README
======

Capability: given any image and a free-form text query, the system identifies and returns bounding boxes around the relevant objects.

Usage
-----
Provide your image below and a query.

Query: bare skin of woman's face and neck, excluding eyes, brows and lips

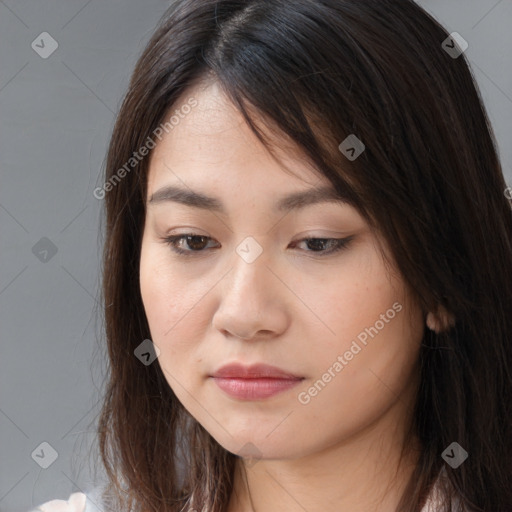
[140,83,425,512]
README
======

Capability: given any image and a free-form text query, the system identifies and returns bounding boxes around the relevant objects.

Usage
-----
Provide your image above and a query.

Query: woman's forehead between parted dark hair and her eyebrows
[148,82,330,193]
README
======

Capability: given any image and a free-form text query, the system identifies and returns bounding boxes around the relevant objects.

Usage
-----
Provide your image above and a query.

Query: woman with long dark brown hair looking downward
[31,0,512,512]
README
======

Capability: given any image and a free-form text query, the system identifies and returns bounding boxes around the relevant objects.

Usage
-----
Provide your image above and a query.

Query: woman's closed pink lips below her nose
[211,363,303,400]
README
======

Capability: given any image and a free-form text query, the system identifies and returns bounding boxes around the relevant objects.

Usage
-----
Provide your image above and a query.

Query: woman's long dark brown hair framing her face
[98,0,512,512]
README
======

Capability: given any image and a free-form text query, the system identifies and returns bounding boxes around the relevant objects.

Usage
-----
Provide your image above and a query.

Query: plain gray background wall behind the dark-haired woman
[0,0,512,512]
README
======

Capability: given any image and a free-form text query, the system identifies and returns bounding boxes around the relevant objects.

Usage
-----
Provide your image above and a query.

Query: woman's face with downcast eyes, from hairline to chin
[140,81,424,459]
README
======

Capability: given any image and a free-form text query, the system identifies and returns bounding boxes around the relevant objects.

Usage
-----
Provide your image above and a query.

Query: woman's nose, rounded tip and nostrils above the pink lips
[212,248,291,340]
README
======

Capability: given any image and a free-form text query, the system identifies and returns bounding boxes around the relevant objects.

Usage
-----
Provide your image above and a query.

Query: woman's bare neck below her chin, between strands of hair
[228,404,420,512]
